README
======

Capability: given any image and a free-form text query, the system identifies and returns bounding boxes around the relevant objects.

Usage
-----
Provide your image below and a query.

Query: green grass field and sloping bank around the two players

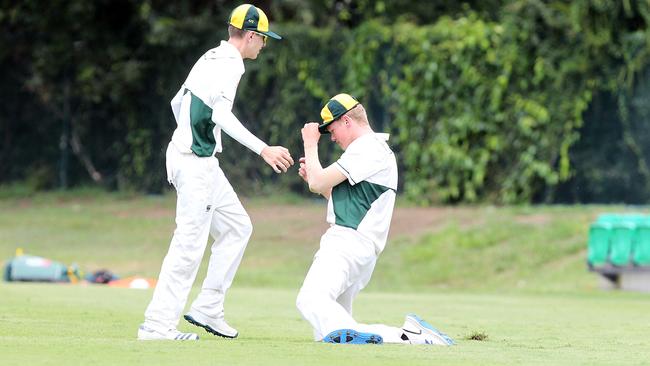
[0,191,650,365]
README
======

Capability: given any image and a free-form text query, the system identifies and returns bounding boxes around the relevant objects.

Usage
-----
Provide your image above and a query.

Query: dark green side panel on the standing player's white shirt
[190,91,216,157]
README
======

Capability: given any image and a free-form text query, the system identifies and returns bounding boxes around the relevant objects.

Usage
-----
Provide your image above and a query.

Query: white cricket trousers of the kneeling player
[296,225,404,343]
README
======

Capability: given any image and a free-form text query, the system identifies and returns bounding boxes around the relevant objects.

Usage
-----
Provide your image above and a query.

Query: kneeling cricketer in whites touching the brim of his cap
[296,94,454,345]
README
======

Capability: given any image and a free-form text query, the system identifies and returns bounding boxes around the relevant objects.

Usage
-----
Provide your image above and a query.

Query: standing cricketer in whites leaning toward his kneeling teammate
[138,4,293,340]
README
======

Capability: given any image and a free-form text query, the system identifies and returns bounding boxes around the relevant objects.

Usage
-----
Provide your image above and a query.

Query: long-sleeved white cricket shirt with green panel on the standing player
[171,41,267,157]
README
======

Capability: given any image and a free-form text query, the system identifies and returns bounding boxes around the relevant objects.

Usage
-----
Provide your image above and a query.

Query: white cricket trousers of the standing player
[145,143,252,330]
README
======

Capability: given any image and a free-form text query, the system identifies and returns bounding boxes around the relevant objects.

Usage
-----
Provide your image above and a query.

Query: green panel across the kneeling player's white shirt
[332,180,391,230]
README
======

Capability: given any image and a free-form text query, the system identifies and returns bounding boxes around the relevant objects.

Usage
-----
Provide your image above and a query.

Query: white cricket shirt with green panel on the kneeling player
[327,133,397,253]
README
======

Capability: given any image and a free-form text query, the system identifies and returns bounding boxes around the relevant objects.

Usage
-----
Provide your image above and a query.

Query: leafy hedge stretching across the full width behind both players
[5,0,650,203]
